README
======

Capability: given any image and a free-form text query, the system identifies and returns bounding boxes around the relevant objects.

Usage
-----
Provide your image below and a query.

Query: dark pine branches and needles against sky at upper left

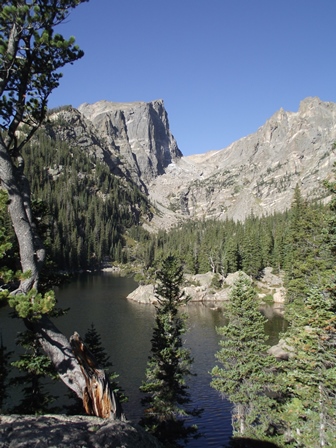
[0,0,86,136]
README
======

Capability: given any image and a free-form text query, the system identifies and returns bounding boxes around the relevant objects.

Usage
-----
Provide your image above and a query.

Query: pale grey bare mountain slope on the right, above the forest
[148,98,336,225]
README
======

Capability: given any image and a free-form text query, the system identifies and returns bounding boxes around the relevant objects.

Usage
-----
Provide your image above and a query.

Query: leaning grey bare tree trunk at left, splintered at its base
[0,141,121,418]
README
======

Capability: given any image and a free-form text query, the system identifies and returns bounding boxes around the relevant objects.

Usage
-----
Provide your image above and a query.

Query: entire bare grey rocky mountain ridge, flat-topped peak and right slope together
[51,98,336,230]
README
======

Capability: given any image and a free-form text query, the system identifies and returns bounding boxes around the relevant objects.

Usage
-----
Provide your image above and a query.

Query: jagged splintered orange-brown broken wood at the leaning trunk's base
[70,332,123,419]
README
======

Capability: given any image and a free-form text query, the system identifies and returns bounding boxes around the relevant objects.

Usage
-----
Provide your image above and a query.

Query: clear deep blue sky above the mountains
[49,0,336,155]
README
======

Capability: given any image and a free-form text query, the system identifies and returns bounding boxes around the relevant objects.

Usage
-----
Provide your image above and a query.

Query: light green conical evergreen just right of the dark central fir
[211,273,276,440]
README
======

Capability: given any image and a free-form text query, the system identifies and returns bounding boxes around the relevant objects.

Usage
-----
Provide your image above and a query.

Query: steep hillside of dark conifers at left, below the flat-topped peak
[21,122,150,271]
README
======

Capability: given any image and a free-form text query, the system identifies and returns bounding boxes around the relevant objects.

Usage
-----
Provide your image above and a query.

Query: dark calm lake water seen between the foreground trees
[0,273,284,448]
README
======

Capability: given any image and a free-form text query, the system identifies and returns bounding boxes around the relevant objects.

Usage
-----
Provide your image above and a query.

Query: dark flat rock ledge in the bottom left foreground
[0,415,162,448]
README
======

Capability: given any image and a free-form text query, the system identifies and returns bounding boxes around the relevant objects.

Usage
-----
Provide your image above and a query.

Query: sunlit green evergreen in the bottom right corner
[280,288,336,448]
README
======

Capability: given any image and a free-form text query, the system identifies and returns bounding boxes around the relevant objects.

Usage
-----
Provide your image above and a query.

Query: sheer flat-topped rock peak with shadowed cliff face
[79,100,182,190]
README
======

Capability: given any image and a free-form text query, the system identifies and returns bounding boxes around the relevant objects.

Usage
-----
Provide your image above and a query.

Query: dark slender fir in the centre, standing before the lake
[140,256,199,446]
